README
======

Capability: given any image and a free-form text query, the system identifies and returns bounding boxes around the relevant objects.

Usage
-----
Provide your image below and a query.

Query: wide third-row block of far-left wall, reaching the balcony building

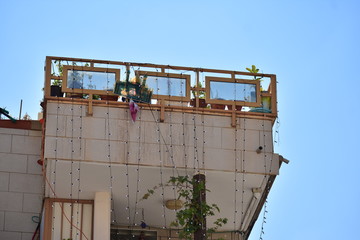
[9,173,43,194]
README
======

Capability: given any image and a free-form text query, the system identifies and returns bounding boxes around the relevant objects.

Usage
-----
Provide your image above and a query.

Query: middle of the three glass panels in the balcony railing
[142,76,186,97]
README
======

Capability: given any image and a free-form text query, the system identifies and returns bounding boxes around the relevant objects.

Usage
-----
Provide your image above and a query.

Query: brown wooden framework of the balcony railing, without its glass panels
[44,56,277,127]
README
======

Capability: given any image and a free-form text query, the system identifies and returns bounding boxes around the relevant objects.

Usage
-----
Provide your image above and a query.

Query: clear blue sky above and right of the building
[0,0,360,240]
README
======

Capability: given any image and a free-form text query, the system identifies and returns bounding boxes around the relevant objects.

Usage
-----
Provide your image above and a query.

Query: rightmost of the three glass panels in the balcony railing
[210,81,256,102]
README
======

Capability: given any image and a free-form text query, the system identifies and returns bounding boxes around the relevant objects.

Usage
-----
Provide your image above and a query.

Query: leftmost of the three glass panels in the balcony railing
[67,70,116,91]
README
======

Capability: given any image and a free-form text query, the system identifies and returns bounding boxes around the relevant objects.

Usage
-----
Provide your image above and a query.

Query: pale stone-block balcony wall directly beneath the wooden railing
[45,103,279,174]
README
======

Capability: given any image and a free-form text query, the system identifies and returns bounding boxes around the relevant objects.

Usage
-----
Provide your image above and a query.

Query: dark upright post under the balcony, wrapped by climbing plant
[193,173,206,240]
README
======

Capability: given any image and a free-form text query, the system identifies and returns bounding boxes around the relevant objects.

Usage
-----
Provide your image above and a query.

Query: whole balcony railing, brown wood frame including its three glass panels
[44,57,277,124]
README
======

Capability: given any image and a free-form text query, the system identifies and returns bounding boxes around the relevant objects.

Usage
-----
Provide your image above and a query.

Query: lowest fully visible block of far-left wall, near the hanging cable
[5,212,37,233]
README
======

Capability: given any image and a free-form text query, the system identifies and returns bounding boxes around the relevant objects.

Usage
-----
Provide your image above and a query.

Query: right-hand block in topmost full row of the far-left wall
[12,135,41,155]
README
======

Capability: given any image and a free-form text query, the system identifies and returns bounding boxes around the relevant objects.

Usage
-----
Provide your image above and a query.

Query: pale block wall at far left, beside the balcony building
[0,128,44,240]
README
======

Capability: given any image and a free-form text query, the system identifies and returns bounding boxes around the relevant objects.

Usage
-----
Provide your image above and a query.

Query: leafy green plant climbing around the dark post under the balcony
[142,176,228,239]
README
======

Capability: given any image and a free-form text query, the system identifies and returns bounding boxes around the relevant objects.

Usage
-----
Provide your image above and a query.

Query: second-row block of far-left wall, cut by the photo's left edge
[0,153,27,173]
